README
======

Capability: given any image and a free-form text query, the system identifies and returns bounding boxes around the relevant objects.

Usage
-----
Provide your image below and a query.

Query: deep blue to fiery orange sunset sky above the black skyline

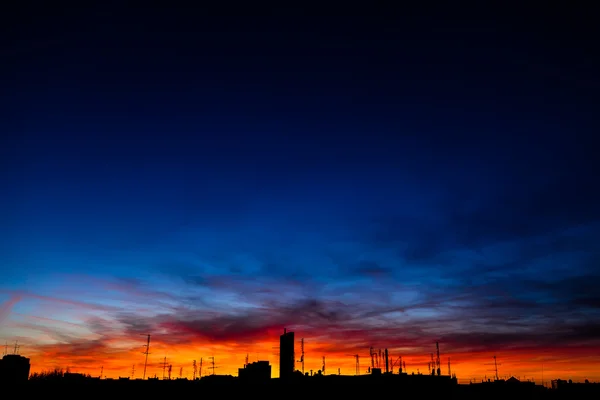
[0,3,600,382]
